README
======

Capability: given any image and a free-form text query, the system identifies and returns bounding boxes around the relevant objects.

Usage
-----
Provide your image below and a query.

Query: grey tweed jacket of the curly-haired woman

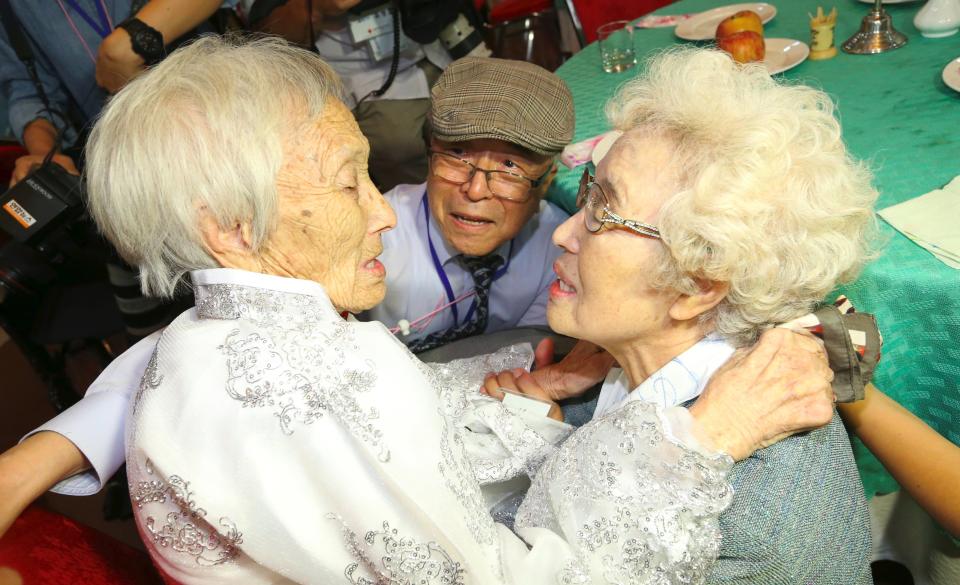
[708,414,873,585]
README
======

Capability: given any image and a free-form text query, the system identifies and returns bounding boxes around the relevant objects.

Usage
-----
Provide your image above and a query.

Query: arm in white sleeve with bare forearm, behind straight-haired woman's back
[0,331,160,536]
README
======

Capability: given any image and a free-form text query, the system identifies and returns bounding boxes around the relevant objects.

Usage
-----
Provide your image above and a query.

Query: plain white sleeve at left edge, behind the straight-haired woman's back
[20,331,160,496]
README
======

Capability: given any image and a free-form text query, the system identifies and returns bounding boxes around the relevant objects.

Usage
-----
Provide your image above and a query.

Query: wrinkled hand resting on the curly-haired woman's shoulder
[690,329,836,461]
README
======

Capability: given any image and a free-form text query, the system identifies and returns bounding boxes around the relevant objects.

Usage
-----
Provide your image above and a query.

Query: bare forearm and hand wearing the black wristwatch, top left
[97,0,230,93]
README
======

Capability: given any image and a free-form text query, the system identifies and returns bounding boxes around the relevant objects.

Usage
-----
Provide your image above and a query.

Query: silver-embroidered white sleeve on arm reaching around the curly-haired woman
[515,401,733,585]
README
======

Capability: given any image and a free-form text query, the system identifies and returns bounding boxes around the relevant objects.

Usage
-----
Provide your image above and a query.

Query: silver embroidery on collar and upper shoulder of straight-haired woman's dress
[196,284,390,461]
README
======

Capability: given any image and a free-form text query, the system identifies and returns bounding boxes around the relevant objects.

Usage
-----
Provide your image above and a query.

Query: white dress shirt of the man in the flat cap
[360,184,568,343]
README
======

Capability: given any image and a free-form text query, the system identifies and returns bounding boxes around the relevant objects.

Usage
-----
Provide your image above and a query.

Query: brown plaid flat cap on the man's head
[430,57,573,156]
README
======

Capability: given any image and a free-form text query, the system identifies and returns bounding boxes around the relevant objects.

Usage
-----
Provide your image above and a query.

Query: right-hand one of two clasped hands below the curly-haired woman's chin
[530,337,615,401]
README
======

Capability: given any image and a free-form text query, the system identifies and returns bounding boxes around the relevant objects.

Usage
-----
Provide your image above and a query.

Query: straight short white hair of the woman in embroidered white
[86,36,340,296]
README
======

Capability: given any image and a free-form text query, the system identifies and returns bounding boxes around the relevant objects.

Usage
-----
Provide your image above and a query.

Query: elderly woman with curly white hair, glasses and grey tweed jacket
[486,50,877,585]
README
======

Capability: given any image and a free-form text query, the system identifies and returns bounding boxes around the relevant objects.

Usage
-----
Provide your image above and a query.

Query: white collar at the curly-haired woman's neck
[593,334,735,418]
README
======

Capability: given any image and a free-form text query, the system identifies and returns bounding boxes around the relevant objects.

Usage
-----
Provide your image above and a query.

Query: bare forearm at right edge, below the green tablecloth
[838,384,960,537]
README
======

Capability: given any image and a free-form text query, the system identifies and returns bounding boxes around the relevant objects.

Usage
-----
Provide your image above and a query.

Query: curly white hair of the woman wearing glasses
[607,48,877,345]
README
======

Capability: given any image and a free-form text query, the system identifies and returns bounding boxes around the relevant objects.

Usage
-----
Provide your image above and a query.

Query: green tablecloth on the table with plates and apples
[550,0,960,497]
